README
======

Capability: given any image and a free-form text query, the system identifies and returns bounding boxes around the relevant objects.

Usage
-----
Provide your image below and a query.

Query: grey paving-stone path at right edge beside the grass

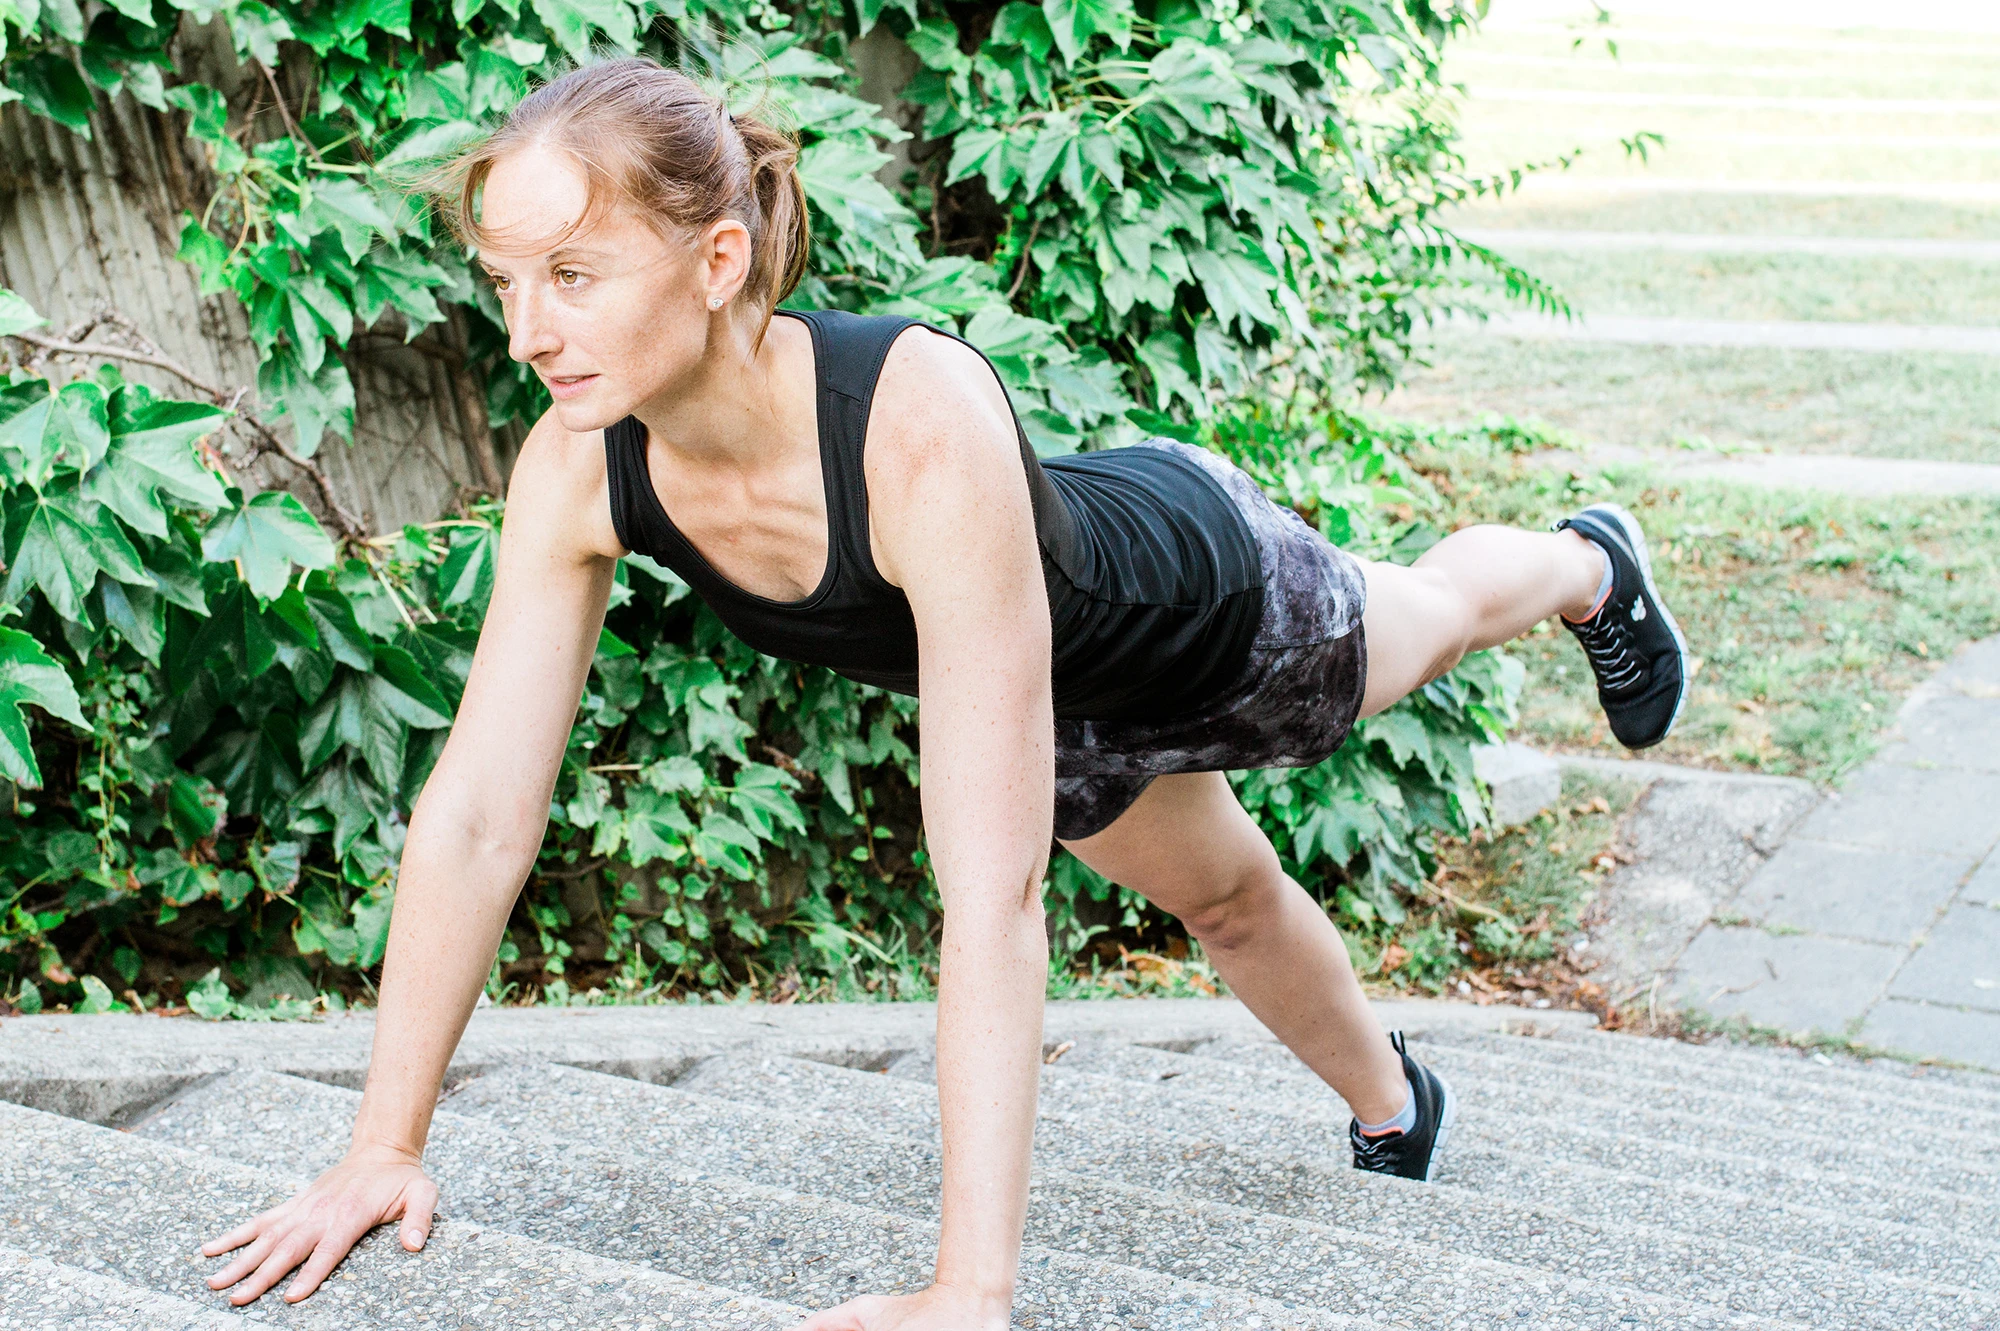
[1670,638,2000,1069]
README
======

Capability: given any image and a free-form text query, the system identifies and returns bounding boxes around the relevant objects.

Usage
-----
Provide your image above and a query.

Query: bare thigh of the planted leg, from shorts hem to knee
[1062,771,1280,917]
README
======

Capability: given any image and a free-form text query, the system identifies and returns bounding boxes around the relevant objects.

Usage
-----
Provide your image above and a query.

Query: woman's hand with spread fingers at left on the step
[202,1147,438,1307]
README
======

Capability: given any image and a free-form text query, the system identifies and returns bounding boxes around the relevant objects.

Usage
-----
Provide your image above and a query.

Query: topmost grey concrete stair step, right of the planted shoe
[1416,1027,2000,1133]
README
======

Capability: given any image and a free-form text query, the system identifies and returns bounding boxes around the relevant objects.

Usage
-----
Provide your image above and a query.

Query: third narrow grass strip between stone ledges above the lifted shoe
[1444,190,2000,240]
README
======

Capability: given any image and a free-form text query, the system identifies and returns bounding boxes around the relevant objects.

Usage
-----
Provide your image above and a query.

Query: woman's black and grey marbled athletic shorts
[1056,438,1368,841]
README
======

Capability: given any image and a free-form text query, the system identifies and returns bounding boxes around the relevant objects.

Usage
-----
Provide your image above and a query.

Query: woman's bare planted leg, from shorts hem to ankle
[1062,767,1408,1123]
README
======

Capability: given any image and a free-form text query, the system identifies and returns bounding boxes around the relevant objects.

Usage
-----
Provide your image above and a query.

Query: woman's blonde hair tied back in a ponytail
[430,56,810,340]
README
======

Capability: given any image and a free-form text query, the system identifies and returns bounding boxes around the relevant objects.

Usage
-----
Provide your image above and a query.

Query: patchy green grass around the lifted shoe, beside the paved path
[1420,439,2000,781]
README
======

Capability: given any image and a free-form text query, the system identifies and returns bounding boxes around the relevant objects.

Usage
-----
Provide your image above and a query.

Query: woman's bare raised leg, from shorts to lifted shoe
[1362,528,1606,715]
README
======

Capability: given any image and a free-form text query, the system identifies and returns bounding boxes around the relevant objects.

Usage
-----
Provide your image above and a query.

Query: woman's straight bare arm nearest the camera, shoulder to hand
[802,334,1054,1331]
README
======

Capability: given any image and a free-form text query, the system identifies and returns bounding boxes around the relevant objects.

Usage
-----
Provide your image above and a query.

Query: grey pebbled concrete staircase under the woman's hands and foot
[0,1003,2000,1331]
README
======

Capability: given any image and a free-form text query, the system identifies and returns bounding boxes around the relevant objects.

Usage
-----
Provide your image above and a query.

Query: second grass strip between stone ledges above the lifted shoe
[1456,242,2000,328]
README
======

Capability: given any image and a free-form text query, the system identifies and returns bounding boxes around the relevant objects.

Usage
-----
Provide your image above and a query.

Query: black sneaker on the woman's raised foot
[1556,504,1688,749]
